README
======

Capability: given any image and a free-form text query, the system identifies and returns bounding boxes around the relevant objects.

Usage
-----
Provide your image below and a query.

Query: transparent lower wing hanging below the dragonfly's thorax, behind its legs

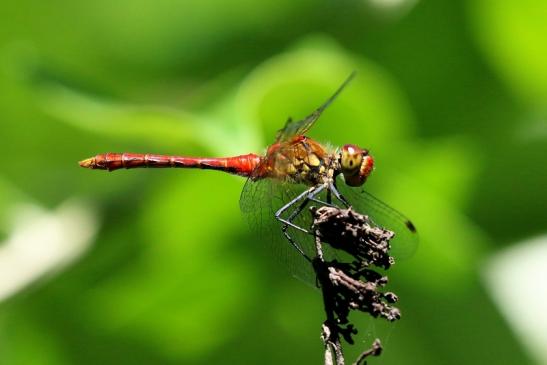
[240,179,342,286]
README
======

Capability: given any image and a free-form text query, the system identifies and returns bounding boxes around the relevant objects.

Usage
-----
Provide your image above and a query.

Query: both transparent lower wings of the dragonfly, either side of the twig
[240,172,418,286]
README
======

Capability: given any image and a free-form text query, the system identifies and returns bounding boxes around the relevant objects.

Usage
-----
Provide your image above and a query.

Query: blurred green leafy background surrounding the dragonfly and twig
[0,0,547,364]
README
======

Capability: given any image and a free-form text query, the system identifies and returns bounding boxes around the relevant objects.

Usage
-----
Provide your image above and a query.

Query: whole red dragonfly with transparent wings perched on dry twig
[80,73,418,284]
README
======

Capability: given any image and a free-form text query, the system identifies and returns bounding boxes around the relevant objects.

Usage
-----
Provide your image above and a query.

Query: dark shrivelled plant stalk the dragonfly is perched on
[311,206,401,365]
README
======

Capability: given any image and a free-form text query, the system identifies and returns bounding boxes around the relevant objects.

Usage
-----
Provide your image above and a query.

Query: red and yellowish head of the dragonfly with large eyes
[340,144,374,186]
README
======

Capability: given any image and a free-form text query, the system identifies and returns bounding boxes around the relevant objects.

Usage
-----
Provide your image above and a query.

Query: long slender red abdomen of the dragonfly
[80,153,261,176]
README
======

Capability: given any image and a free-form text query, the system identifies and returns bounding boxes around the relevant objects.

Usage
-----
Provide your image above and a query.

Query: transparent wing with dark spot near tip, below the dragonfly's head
[337,178,419,259]
